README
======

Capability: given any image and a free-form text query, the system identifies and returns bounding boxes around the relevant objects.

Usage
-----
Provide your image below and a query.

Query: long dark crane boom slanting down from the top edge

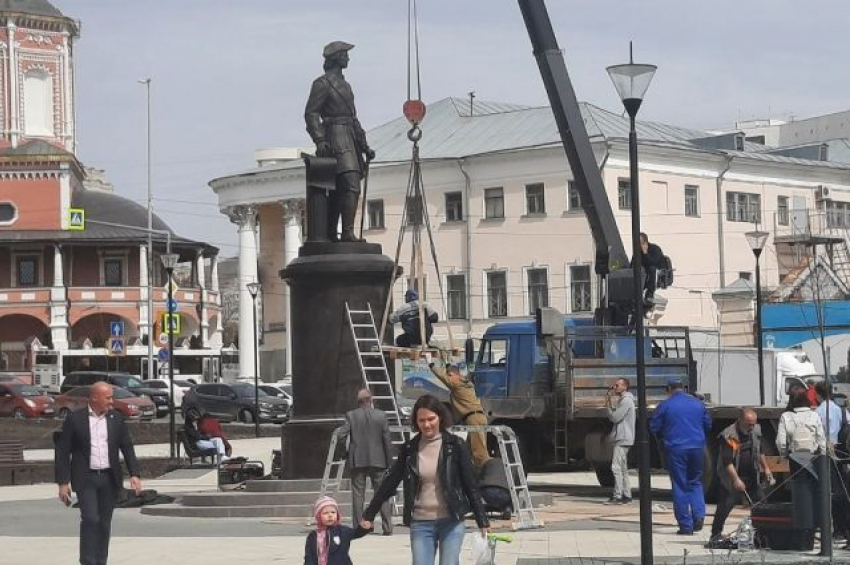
[518,0,629,275]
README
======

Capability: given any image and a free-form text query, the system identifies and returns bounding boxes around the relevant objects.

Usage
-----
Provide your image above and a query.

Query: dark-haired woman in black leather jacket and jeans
[360,394,490,565]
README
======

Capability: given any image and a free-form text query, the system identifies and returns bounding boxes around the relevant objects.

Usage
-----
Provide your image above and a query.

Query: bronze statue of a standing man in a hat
[304,41,375,241]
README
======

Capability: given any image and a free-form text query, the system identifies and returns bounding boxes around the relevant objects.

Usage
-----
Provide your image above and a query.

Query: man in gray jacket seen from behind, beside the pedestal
[340,388,393,536]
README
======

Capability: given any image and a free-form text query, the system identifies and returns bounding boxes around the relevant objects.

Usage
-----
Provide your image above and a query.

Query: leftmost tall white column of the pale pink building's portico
[228,206,257,378]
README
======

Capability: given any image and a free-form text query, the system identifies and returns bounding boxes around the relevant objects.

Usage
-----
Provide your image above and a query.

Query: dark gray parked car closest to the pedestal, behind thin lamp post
[183,383,289,423]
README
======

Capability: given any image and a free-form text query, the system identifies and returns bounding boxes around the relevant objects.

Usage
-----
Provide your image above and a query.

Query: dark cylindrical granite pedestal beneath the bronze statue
[280,242,393,479]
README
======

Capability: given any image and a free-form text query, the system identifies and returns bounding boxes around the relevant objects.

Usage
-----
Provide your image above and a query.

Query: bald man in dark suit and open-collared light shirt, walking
[55,382,142,565]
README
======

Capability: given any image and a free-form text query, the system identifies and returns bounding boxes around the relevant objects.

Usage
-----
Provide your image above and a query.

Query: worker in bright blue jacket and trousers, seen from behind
[649,378,711,536]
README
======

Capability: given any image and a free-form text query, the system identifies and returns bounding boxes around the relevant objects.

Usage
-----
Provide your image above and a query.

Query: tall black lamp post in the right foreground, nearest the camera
[607,43,657,565]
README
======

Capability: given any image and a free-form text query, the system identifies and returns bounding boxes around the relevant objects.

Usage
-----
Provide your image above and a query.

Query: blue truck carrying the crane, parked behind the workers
[458,310,781,492]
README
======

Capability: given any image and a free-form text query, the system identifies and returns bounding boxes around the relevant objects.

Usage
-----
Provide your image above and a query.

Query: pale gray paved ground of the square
[0,438,850,565]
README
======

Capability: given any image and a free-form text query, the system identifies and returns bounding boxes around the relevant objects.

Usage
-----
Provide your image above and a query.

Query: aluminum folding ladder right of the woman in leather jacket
[449,426,543,530]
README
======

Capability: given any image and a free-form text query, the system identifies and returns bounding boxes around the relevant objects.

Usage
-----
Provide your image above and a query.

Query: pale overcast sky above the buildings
[68,0,850,256]
